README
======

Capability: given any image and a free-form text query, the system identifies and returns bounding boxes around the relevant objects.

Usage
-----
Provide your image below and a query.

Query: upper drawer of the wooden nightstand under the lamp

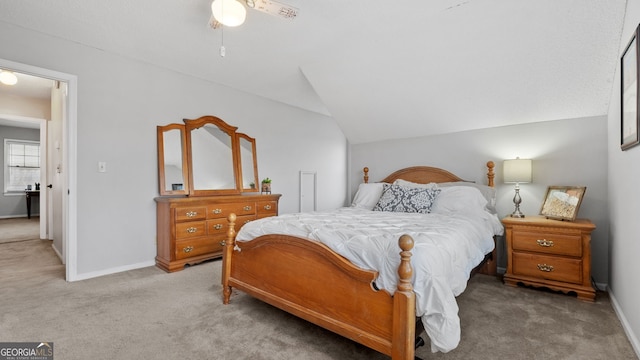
[512,230,582,257]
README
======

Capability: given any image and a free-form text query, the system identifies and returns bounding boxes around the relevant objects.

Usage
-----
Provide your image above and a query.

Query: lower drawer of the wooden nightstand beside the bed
[511,252,582,284]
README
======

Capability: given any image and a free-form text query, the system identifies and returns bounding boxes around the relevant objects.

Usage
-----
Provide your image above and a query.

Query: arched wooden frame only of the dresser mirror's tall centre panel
[184,115,242,196]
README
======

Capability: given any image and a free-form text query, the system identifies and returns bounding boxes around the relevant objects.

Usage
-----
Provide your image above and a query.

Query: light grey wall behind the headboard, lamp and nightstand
[350,116,609,288]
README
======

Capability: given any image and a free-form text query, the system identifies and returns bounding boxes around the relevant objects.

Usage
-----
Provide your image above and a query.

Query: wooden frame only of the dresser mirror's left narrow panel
[157,124,190,195]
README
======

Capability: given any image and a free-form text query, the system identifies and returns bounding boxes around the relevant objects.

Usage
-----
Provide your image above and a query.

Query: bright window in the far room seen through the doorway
[4,139,40,193]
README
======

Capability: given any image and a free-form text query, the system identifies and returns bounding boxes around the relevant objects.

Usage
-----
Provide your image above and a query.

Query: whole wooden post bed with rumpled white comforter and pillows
[222,161,501,360]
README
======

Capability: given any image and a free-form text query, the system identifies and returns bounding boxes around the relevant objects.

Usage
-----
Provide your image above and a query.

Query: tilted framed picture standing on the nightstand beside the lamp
[540,186,587,221]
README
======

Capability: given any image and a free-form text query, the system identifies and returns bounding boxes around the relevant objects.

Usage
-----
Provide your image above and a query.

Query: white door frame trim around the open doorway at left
[0,58,79,281]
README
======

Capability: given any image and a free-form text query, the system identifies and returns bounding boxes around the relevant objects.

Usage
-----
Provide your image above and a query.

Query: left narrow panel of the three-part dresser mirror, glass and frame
[158,124,189,195]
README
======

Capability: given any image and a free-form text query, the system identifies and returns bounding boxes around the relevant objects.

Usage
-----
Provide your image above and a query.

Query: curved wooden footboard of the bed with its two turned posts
[222,214,416,360]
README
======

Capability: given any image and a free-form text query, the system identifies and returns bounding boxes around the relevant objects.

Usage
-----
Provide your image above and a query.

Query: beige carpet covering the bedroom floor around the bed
[0,240,636,360]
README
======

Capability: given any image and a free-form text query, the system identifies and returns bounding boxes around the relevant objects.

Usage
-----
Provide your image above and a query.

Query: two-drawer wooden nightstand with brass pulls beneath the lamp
[502,216,596,301]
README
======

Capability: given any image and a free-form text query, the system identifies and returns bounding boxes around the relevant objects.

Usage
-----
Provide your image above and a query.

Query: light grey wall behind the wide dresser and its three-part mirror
[0,19,347,278]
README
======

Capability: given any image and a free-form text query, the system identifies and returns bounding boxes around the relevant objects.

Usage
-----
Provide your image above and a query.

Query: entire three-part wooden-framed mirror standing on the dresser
[158,116,259,196]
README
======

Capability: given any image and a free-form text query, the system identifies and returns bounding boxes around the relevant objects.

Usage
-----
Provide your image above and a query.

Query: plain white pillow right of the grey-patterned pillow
[431,186,487,214]
